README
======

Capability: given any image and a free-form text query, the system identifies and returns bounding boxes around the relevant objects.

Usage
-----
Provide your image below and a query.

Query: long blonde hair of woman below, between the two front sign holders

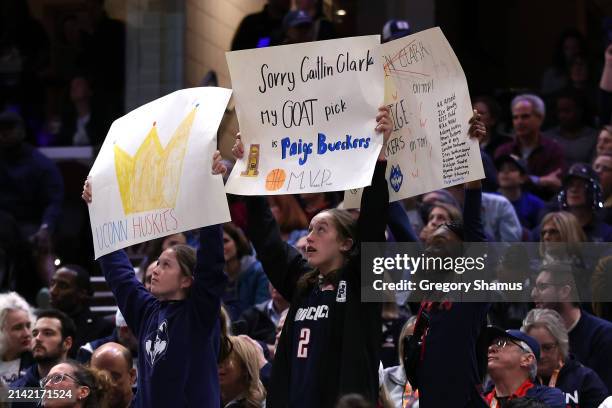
[229,336,266,408]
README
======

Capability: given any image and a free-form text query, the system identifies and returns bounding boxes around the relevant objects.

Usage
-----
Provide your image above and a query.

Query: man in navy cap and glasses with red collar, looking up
[485,326,565,408]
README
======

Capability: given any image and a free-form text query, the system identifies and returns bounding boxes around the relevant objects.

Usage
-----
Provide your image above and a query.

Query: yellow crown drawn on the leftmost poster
[114,105,198,215]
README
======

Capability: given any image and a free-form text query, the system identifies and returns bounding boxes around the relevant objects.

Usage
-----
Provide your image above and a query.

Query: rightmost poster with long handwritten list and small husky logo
[344,27,484,208]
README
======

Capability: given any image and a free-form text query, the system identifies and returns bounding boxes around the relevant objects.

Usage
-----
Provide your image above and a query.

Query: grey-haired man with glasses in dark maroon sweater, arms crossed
[495,94,565,200]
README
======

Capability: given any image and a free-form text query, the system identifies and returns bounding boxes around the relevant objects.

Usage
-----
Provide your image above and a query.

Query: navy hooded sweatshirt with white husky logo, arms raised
[100,225,227,408]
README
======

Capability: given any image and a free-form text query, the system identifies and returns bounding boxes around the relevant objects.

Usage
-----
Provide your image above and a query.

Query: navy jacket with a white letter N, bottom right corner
[555,355,608,408]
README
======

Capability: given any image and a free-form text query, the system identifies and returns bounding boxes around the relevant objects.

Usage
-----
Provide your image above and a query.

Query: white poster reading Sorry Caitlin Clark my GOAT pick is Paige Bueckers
[225,36,383,195]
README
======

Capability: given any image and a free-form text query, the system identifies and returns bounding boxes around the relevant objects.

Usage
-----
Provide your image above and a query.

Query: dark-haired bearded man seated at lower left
[11,309,76,390]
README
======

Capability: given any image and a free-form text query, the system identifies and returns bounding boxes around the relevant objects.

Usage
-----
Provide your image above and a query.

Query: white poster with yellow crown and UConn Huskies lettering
[89,87,231,259]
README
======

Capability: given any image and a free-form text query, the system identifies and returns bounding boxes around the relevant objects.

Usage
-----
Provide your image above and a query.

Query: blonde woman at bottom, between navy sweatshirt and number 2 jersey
[219,336,266,408]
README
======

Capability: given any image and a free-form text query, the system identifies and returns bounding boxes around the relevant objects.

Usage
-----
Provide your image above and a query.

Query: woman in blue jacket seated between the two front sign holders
[223,222,270,321]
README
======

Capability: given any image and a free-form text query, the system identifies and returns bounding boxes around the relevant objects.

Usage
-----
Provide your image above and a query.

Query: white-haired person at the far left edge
[0,292,34,384]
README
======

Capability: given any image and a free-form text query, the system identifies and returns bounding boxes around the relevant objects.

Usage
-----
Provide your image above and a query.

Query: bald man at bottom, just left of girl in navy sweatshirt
[90,342,136,408]
